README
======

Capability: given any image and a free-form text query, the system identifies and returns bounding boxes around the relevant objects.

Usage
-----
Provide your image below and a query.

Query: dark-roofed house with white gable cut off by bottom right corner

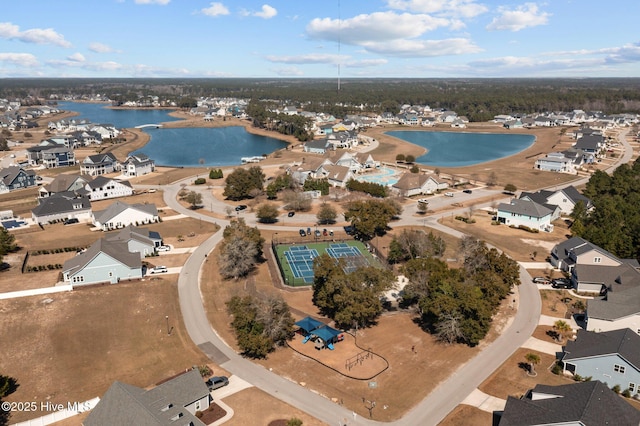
[498,380,640,426]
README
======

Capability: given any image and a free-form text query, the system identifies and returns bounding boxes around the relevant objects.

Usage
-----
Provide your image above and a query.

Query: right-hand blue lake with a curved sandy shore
[386,130,535,167]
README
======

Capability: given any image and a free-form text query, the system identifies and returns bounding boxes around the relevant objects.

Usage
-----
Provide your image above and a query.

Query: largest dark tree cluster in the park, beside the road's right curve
[402,237,520,346]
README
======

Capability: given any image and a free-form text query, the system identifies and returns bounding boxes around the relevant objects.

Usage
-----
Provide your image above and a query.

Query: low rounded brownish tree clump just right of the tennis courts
[387,229,447,263]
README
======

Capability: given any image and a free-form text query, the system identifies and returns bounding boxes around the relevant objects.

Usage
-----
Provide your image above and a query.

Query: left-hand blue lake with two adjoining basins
[58,102,287,167]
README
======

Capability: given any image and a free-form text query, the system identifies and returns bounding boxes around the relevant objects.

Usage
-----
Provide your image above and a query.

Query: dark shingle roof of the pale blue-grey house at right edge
[562,328,640,369]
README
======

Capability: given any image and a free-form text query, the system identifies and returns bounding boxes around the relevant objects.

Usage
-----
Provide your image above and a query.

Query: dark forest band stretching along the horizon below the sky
[5,78,640,121]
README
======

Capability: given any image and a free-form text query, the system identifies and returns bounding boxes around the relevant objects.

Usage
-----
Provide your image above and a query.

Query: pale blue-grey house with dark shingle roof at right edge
[560,328,640,395]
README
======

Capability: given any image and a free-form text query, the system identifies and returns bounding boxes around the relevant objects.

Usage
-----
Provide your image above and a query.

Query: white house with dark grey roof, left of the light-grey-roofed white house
[31,192,93,224]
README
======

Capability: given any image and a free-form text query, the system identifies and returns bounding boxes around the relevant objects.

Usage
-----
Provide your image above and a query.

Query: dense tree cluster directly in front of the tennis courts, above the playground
[313,253,395,328]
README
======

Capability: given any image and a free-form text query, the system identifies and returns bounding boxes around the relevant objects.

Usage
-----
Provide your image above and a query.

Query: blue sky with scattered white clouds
[0,0,640,78]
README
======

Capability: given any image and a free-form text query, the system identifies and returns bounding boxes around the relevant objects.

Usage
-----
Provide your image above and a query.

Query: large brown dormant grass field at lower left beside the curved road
[0,276,208,422]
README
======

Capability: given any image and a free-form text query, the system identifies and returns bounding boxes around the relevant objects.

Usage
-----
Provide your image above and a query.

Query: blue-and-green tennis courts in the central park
[275,241,379,286]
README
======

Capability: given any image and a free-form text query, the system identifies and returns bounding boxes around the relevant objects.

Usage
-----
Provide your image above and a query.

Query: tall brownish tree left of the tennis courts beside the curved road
[218,218,264,279]
